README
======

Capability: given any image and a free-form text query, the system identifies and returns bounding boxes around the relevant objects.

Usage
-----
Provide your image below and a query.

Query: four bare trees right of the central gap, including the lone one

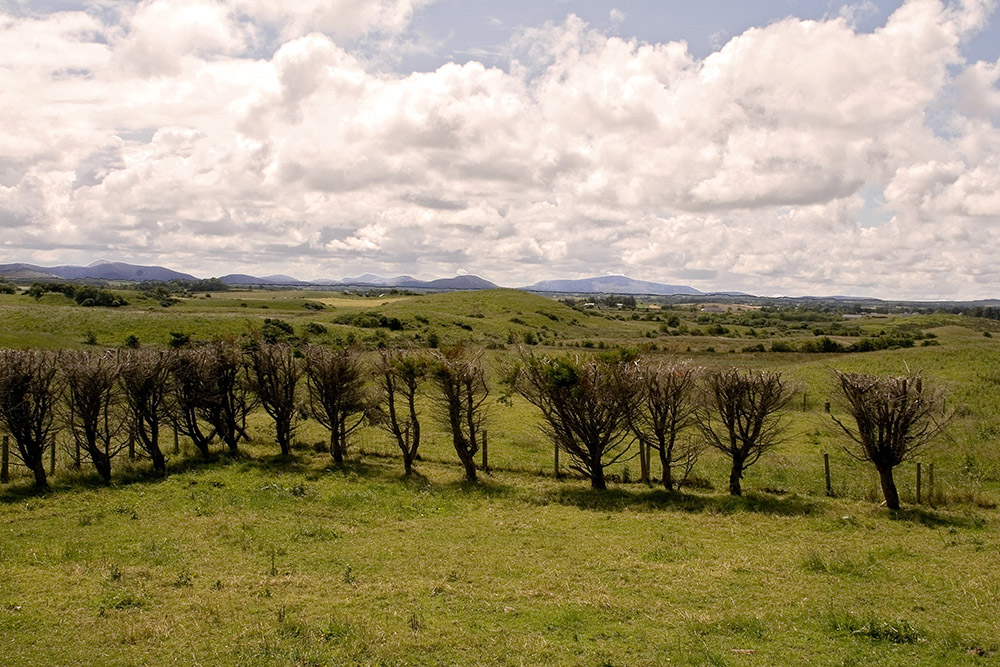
[508,352,950,509]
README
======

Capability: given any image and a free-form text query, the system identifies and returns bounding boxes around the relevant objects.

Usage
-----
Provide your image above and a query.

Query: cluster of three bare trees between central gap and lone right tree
[509,353,772,495]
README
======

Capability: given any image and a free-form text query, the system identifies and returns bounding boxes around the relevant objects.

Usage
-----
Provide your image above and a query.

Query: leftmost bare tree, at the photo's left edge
[0,350,61,490]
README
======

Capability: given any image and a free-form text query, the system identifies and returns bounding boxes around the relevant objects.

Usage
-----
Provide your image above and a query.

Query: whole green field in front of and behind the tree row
[0,290,1000,665]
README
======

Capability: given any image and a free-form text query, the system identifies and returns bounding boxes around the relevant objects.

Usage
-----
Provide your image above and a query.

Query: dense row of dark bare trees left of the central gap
[0,344,489,488]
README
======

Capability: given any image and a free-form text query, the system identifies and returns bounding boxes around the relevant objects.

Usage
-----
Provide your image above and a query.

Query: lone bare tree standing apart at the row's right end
[831,371,950,510]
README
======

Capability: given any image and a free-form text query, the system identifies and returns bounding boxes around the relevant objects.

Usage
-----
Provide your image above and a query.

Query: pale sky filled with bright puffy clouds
[0,0,1000,300]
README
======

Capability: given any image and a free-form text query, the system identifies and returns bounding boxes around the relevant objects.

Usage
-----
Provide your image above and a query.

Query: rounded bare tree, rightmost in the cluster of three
[697,368,792,496]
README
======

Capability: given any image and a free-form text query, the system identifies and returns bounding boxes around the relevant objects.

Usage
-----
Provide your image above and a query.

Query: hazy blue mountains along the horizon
[0,260,703,296]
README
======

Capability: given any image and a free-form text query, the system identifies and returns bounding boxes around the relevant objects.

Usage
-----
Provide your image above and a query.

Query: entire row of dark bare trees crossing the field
[0,344,947,509]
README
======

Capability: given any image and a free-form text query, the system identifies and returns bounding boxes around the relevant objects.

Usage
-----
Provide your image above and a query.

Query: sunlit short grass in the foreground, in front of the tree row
[0,451,1000,665]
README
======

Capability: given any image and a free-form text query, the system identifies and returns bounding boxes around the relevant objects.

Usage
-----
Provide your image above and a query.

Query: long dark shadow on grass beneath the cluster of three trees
[540,488,822,516]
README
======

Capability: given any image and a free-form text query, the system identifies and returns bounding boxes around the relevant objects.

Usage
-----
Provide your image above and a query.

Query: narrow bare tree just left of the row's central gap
[431,346,490,482]
